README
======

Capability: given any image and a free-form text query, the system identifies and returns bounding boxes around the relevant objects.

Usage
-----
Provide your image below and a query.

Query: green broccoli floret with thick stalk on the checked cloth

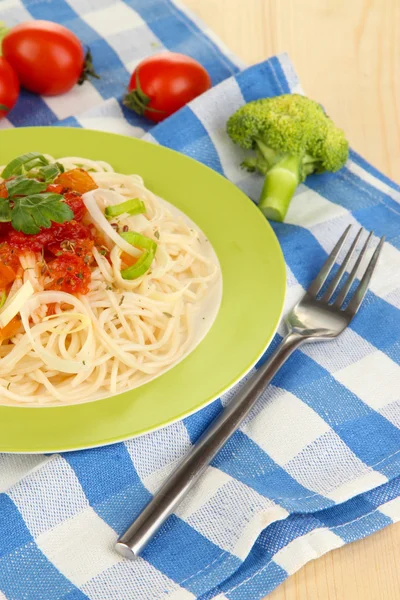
[227,94,349,221]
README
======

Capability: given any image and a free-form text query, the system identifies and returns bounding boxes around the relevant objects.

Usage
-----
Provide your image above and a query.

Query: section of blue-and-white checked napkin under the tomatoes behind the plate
[0,0,239,131]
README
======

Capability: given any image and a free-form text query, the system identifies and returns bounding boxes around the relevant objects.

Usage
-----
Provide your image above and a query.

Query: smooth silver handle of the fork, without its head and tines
[116,332,305,559]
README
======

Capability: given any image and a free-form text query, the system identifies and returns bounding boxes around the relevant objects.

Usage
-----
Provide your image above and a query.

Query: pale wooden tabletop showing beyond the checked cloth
[184,0,400,600]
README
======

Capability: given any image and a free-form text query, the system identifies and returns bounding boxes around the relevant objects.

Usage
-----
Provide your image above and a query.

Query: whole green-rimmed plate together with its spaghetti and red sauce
[0,128,285,452]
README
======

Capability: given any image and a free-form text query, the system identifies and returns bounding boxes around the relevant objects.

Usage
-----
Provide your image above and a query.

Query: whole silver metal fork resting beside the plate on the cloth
[116,225,385,559]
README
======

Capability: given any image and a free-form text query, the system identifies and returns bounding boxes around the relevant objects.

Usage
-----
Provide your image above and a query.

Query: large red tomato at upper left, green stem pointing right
[3,21,97,96]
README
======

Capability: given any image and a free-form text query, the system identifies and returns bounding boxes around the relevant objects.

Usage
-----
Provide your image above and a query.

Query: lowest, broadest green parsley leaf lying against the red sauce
[11,193,74,234]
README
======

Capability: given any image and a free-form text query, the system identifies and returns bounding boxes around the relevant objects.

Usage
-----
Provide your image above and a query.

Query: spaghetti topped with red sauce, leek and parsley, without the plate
[0,153,221,405]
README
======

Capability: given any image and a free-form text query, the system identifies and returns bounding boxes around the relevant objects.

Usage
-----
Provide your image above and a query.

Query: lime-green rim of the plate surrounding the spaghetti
[0,127,286,452]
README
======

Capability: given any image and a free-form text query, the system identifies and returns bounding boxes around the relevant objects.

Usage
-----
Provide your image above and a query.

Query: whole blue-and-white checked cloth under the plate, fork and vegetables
[0,0,400,600]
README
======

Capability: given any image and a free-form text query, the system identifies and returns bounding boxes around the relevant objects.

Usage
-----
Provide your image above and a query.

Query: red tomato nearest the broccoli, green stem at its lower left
[124,52,211,122]
